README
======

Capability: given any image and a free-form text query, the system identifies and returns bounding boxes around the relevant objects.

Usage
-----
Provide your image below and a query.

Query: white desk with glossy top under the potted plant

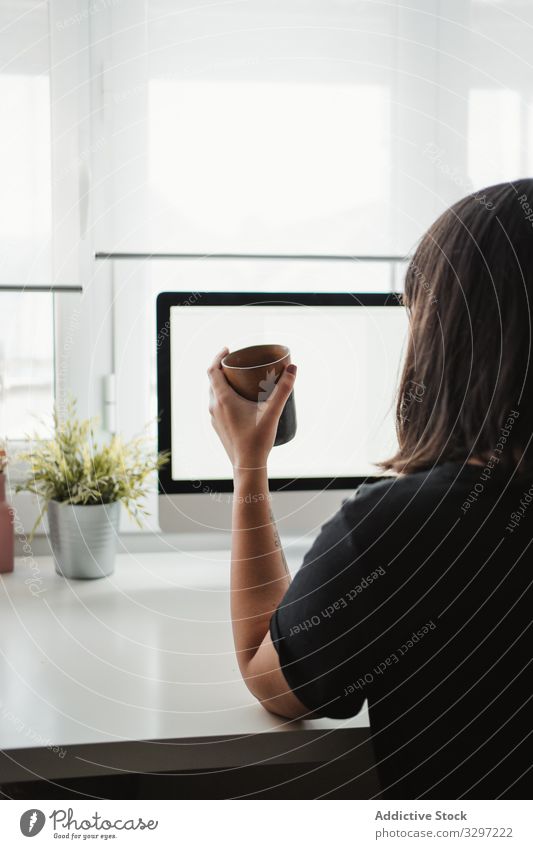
[0,551,368,783]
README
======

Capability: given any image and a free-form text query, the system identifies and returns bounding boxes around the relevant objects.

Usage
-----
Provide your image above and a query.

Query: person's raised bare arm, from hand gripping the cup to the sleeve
[209,344,309,718]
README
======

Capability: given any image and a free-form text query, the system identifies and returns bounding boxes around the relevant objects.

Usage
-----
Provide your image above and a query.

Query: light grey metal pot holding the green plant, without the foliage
[48,501,120,578]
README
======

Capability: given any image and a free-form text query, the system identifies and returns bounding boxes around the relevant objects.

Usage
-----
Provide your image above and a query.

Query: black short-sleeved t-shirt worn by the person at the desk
[270,462,533,799]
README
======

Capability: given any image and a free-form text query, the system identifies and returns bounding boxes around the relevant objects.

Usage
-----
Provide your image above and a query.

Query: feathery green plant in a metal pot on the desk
[17,402,168,578]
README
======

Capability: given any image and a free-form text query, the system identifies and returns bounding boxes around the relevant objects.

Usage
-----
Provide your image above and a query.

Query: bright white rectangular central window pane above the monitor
[148,80,391,254]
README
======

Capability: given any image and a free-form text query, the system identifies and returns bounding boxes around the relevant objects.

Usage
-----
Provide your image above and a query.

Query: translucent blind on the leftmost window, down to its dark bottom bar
[0,2,52,287]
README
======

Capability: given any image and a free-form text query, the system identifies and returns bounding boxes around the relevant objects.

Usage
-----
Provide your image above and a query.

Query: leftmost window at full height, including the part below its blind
[0,2,54,439]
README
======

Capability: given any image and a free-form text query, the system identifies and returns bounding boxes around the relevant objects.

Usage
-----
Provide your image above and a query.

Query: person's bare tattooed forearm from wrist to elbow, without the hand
[231,468,290,672]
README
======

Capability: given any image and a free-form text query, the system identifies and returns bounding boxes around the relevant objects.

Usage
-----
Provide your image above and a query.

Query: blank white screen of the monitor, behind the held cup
[170,305,407,482]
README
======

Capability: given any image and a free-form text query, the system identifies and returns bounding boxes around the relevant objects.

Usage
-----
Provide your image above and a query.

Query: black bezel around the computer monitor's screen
[156,291,402,495]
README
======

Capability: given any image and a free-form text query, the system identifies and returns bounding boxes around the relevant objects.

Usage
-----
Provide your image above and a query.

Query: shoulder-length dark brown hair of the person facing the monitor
[380,179,533,474]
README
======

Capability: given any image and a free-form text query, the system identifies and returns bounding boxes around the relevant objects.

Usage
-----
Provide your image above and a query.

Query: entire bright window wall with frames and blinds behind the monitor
[6,0,533,524]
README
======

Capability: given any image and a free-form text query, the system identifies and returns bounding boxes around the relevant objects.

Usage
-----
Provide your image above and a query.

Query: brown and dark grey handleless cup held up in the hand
[222,345,296,445]
